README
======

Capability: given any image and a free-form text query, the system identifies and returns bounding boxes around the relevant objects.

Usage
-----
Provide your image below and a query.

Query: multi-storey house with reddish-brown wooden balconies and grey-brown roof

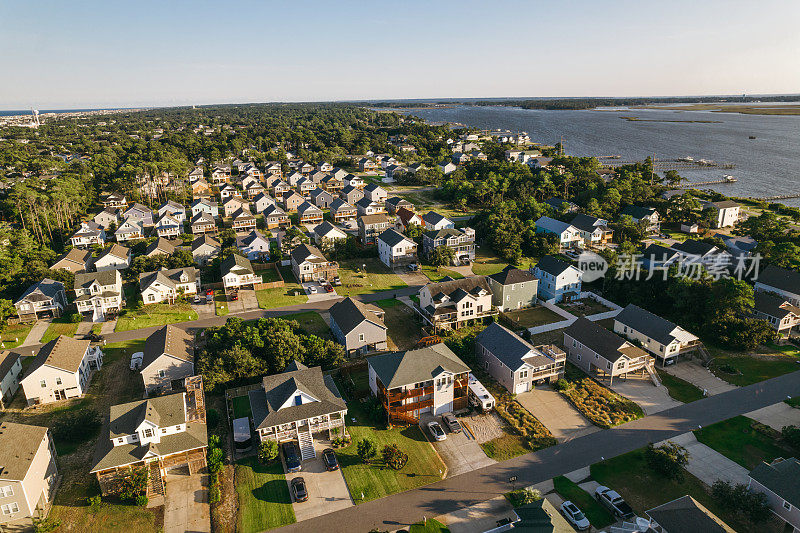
[367,343,476,425]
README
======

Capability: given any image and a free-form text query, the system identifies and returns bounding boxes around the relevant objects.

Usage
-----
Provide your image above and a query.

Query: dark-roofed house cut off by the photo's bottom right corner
[747,457,800,531]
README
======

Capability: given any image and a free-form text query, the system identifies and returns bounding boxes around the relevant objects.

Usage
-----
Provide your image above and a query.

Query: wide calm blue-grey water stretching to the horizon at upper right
[410,106,800,206]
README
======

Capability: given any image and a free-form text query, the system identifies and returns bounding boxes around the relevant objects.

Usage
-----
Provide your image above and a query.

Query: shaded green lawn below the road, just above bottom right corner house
[694,416,792,470]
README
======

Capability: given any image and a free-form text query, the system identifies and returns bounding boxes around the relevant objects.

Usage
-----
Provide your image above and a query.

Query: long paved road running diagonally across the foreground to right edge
[281,372,800,533]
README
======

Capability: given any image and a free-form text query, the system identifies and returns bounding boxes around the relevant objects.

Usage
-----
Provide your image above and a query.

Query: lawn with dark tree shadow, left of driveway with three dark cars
[236,457,295,533]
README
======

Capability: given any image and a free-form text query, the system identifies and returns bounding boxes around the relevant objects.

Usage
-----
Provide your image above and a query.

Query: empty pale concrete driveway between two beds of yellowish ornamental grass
[517,386,600,442]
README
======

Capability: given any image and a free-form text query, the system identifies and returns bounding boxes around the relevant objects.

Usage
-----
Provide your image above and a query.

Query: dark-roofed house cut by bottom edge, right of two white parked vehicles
[645,495,736,533]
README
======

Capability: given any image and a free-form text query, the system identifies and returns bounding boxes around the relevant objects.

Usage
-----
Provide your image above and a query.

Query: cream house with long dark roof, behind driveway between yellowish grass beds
[475,322,567,394]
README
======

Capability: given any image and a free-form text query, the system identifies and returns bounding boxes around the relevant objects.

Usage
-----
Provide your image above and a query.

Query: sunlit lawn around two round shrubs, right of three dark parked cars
[336,402,445,504]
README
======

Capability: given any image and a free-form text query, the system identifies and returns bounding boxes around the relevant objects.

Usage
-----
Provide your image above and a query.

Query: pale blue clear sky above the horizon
[0,0,800,110]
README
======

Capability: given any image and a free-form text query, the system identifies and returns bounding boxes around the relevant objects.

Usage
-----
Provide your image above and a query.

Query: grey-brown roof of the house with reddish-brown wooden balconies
[367,343,469,389]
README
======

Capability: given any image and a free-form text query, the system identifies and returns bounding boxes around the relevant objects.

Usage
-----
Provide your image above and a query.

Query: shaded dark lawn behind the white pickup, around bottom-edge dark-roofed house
[590,448,764,531]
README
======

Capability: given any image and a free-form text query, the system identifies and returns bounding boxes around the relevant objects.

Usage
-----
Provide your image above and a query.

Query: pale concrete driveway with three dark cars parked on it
[281,440,353,522]
